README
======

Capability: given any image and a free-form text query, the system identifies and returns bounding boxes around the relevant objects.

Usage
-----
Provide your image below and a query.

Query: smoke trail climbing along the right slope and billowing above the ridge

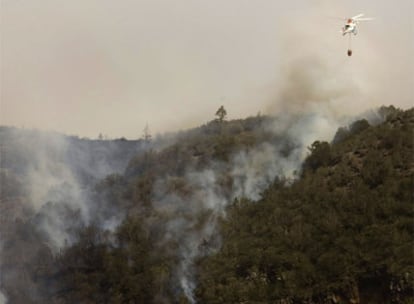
[149,37,394,303]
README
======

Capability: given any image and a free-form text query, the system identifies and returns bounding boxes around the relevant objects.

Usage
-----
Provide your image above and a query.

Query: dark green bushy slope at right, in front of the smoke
[196,109,414,304]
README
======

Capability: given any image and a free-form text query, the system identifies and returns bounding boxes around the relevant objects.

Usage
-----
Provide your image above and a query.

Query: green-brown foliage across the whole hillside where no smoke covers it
[0,108,414,304]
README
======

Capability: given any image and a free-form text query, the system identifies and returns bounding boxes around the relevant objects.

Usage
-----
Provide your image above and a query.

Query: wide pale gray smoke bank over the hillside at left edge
[0,127,142,303]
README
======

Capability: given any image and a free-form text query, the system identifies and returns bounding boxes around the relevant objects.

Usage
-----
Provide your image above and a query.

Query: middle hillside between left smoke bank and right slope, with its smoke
[49,117,299,303]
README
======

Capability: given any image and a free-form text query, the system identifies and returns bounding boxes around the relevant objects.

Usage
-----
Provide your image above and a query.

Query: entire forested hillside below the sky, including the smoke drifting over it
[0,106,414,304]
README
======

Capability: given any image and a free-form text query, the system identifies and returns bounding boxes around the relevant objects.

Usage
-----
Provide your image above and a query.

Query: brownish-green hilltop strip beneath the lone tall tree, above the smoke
[125,117,275,188]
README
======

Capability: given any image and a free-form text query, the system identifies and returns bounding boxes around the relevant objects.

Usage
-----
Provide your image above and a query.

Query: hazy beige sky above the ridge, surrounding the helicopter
[0,0,414,138]
